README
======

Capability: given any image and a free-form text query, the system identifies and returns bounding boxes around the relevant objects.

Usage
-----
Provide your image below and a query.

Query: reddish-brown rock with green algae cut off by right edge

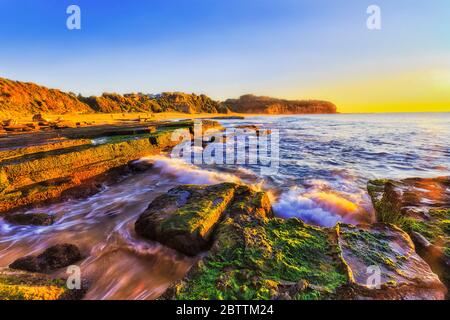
[368,177,450,287]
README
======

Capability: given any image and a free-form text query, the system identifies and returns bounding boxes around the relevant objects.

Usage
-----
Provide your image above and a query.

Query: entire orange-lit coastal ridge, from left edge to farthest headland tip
[0,78,336,119]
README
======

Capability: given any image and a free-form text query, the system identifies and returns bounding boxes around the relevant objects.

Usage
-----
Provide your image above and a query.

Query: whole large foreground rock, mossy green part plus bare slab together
[154,182,446,300]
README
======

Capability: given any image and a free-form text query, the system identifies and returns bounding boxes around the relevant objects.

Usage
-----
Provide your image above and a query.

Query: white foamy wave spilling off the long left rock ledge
[139,156,240,184]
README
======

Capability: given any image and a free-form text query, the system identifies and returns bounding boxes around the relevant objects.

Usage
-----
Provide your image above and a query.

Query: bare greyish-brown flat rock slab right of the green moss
[337,224,446,300]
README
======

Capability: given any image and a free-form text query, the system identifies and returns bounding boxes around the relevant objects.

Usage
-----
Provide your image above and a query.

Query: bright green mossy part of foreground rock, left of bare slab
[165,215,347,300]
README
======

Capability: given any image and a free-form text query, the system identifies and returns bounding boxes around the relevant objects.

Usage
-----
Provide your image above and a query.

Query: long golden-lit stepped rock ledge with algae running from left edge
[0,121,221,213]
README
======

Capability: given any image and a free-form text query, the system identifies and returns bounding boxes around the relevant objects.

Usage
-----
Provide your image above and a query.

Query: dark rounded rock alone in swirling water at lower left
[9,244,82,273]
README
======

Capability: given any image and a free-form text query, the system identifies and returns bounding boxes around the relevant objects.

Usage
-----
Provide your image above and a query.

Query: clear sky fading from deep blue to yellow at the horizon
[0,0,450,112]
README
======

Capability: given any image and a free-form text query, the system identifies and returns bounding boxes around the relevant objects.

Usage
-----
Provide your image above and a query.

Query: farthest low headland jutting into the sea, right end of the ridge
[224,94,337,114]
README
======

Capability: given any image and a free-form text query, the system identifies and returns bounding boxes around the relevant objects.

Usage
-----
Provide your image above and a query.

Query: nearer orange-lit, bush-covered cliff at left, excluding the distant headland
[0,78,227,119]
